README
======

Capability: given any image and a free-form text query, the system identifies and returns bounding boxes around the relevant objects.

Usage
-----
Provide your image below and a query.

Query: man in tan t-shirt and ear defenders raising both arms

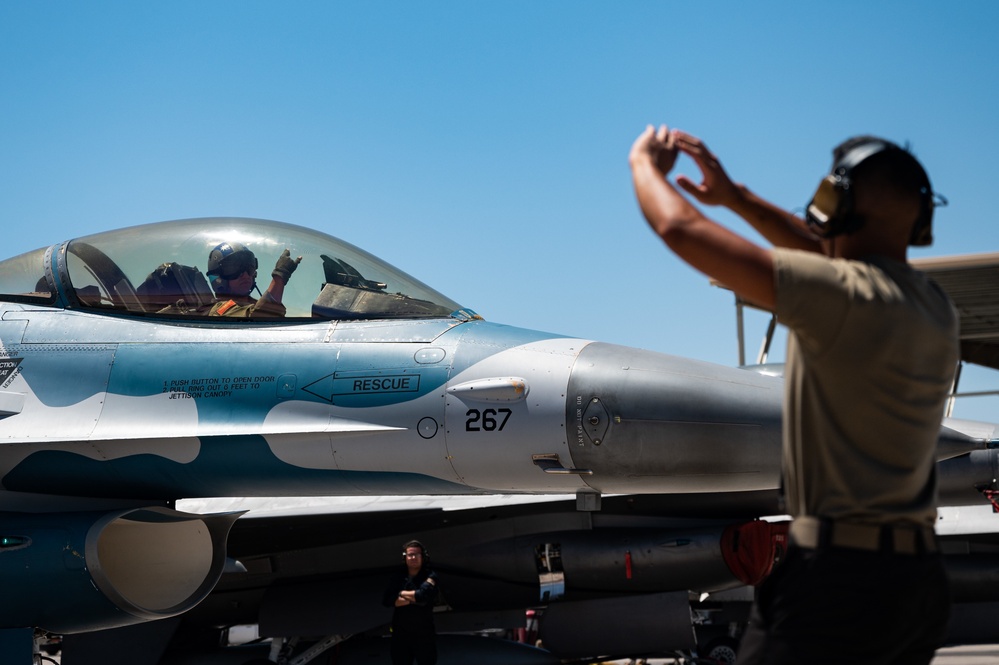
[630,126,959,665]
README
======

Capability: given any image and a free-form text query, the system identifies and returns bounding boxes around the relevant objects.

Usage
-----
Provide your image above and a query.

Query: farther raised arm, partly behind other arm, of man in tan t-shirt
[672,130,822,252]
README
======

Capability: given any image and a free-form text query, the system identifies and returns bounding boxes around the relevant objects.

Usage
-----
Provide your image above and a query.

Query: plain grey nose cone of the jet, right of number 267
[566,343,782,493]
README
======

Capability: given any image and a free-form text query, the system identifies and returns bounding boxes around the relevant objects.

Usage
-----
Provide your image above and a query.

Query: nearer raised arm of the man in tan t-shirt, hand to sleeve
[629,126,775,310]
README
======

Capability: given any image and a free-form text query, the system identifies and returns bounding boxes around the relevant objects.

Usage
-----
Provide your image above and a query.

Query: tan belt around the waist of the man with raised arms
[790,515,937,555]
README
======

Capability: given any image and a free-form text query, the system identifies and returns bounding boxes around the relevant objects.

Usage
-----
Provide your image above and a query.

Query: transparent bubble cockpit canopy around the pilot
[0,217,465,319]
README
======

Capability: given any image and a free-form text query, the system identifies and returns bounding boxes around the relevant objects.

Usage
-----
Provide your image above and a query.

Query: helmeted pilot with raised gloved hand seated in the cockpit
[207,242,302,318]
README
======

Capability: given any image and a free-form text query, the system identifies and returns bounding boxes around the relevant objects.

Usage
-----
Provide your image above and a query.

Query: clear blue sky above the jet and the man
[0,0,999,421]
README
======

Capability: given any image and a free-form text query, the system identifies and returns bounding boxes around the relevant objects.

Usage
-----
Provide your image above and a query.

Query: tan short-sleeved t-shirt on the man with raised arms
[774,249,959,526]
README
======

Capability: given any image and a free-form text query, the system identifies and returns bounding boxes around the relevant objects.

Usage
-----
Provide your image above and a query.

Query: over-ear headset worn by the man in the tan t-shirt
[805,138,947,247]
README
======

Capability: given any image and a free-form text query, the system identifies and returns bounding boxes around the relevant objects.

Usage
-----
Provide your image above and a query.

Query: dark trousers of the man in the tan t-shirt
[739,546,950,665]
